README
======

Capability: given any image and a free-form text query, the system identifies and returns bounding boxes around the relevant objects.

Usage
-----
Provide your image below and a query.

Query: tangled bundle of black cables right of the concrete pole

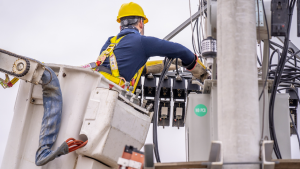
[258,0,300,159]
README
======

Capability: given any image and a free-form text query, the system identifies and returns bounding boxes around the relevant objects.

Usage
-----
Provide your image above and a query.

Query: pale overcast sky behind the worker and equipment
[0,0,300,164]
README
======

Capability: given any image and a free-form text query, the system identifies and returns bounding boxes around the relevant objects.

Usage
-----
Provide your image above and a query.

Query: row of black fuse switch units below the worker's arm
[142,72,201,128]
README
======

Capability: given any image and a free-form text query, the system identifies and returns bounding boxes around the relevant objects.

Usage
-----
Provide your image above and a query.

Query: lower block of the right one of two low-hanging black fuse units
[172,102,185,128]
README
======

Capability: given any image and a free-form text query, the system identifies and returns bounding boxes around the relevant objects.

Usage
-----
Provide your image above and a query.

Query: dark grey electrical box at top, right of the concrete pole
[271,0,289,36]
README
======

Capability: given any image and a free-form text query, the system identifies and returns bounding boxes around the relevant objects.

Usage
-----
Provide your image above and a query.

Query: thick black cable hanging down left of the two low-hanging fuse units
[153,58,173,163]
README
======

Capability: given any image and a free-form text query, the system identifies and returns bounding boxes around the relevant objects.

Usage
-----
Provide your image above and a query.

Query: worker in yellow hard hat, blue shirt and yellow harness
[96,2,208,91]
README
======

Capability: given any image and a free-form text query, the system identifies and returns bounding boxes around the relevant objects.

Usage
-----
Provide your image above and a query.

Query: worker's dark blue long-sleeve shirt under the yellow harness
[100,28,195,81]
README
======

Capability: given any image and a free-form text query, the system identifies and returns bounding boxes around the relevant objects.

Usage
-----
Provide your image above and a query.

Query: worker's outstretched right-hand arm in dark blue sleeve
[141,36,195,66]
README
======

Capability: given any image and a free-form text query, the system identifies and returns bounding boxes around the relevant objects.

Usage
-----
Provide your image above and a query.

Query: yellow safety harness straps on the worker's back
[94,35,145,93]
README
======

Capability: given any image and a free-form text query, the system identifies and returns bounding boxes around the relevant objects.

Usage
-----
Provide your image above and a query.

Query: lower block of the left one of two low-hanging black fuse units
[157,101,171,127]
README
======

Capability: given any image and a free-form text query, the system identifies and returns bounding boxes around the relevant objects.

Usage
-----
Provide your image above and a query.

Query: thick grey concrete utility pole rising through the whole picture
[217,0,260,169]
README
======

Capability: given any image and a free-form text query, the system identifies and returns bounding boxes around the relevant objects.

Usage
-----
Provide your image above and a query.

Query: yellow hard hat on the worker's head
[117,2,148,24]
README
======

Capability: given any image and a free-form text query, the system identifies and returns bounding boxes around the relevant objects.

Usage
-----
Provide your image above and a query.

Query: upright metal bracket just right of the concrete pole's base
[261,140,275,169]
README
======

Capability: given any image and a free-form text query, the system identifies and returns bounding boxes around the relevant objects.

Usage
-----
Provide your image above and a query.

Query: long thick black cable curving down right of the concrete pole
[269,1,295,159]
